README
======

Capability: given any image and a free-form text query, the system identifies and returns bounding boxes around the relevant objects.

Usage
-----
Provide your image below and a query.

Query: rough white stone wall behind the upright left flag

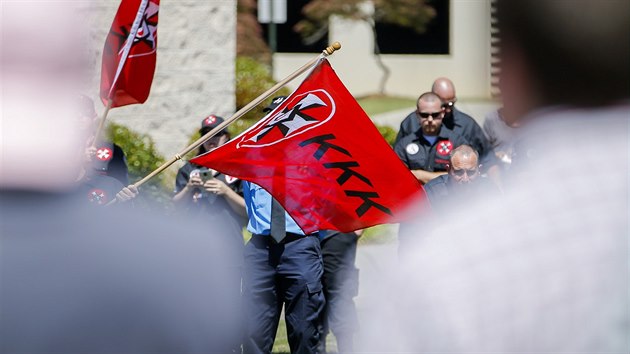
[84,0,236,158]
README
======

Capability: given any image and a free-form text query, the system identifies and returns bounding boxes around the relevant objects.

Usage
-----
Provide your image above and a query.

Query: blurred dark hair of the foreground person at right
[497,0,630,107]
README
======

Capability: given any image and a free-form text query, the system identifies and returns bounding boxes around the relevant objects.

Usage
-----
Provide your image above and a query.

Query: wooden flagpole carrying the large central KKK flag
[107,42,341,205]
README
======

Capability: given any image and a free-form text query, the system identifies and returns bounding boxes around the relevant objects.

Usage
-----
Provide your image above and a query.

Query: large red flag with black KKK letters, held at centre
[192,59,424,233]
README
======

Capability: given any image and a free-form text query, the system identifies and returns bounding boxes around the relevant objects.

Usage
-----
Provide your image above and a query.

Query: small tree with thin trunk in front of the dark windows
[294,0,436,95]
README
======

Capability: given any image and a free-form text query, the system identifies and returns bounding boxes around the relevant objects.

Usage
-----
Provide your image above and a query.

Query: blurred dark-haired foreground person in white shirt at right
[362,0,630,353]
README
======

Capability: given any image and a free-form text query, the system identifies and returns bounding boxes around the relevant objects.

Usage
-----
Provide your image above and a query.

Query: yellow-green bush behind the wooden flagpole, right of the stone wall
[235,56,291,136]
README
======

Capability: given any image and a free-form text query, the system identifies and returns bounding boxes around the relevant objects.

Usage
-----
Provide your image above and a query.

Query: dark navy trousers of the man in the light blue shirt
[243,234,325,354]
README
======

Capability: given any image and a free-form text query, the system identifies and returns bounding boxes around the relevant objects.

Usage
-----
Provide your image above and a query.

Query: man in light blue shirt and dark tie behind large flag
[243,182,325,353]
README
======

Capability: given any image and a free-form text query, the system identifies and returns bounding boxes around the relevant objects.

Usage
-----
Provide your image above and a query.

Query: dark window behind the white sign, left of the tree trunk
[261,0,328,53]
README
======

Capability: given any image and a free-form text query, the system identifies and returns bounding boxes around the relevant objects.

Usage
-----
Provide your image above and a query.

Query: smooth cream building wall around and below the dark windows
[273,0,491,99]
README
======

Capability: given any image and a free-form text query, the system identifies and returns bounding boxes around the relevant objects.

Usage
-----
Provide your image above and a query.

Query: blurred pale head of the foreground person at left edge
[0,1,86,190]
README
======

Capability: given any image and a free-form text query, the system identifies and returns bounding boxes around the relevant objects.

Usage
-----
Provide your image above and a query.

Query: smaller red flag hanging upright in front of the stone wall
[101,0,160,107]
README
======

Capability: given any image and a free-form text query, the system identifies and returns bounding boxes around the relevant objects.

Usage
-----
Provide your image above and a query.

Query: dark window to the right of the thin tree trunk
[376,0,450,54]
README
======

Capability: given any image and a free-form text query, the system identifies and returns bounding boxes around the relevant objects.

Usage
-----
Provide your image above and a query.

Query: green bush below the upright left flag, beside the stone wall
[106,122,171,209]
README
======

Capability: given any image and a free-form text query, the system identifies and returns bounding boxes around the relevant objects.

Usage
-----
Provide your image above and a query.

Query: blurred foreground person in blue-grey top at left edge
[0,0,239,353]
